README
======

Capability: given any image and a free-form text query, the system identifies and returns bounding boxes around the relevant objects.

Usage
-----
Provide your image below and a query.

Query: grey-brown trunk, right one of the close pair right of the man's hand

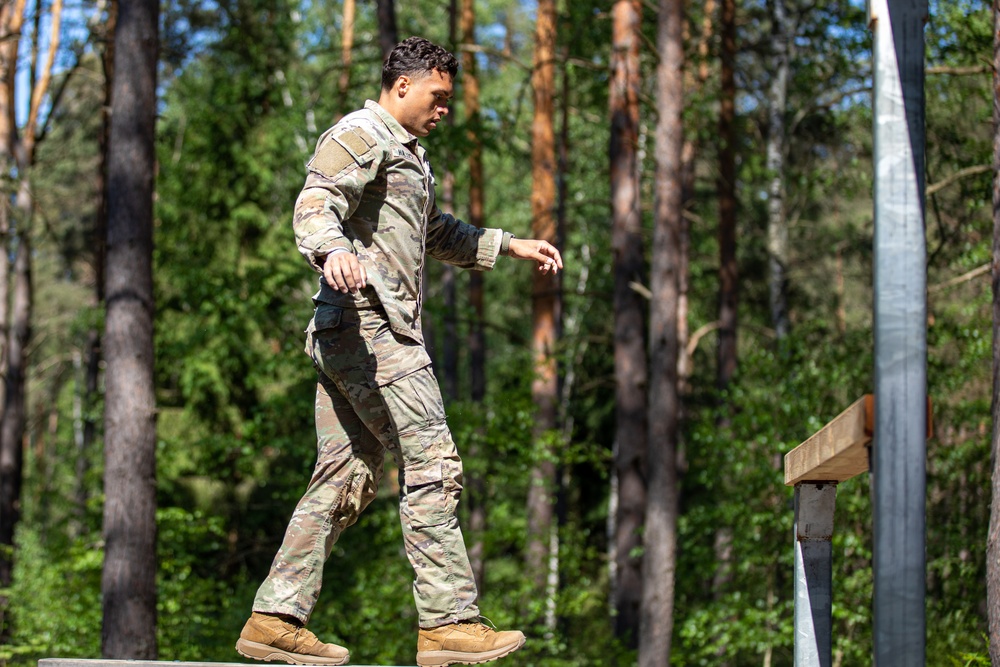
[639,0,684,667]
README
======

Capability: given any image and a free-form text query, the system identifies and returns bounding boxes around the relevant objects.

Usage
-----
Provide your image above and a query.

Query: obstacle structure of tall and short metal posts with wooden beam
[785,0,930,667]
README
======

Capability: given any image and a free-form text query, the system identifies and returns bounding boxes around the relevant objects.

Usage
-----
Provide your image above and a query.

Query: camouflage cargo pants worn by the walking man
[253,304,479,628]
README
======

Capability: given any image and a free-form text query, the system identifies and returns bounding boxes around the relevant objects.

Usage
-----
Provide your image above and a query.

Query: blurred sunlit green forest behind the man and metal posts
[0,0,993,667]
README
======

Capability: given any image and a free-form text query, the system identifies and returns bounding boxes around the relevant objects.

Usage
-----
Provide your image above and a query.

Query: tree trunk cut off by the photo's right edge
[986,0,1000,665]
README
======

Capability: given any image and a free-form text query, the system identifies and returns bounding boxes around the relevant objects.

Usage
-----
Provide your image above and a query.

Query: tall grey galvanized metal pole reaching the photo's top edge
[869,0,927,667]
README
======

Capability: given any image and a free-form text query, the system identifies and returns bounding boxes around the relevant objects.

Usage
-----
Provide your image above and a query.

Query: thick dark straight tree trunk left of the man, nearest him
[101,0,159,659]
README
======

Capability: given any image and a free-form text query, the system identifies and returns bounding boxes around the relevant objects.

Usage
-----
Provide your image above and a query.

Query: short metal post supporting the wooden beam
[795,482,837,667]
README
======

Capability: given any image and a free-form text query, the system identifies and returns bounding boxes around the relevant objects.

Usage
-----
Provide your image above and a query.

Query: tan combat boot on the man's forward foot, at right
[417,621,524,667]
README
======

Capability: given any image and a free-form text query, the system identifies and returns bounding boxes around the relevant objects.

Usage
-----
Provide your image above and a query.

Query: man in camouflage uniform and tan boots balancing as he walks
[236,37,563,667]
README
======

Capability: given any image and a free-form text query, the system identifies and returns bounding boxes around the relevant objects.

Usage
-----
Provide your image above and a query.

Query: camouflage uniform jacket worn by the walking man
[293,100,503,350]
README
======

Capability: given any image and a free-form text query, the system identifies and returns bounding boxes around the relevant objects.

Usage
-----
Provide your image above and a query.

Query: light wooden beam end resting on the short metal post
[785,394,874,486]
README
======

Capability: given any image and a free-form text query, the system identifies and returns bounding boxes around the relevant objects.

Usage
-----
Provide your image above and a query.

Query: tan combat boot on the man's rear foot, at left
[236,612,351,665]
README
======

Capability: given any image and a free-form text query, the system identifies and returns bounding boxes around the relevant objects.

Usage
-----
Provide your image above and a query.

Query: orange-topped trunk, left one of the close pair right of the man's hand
[609,0,647,647]
